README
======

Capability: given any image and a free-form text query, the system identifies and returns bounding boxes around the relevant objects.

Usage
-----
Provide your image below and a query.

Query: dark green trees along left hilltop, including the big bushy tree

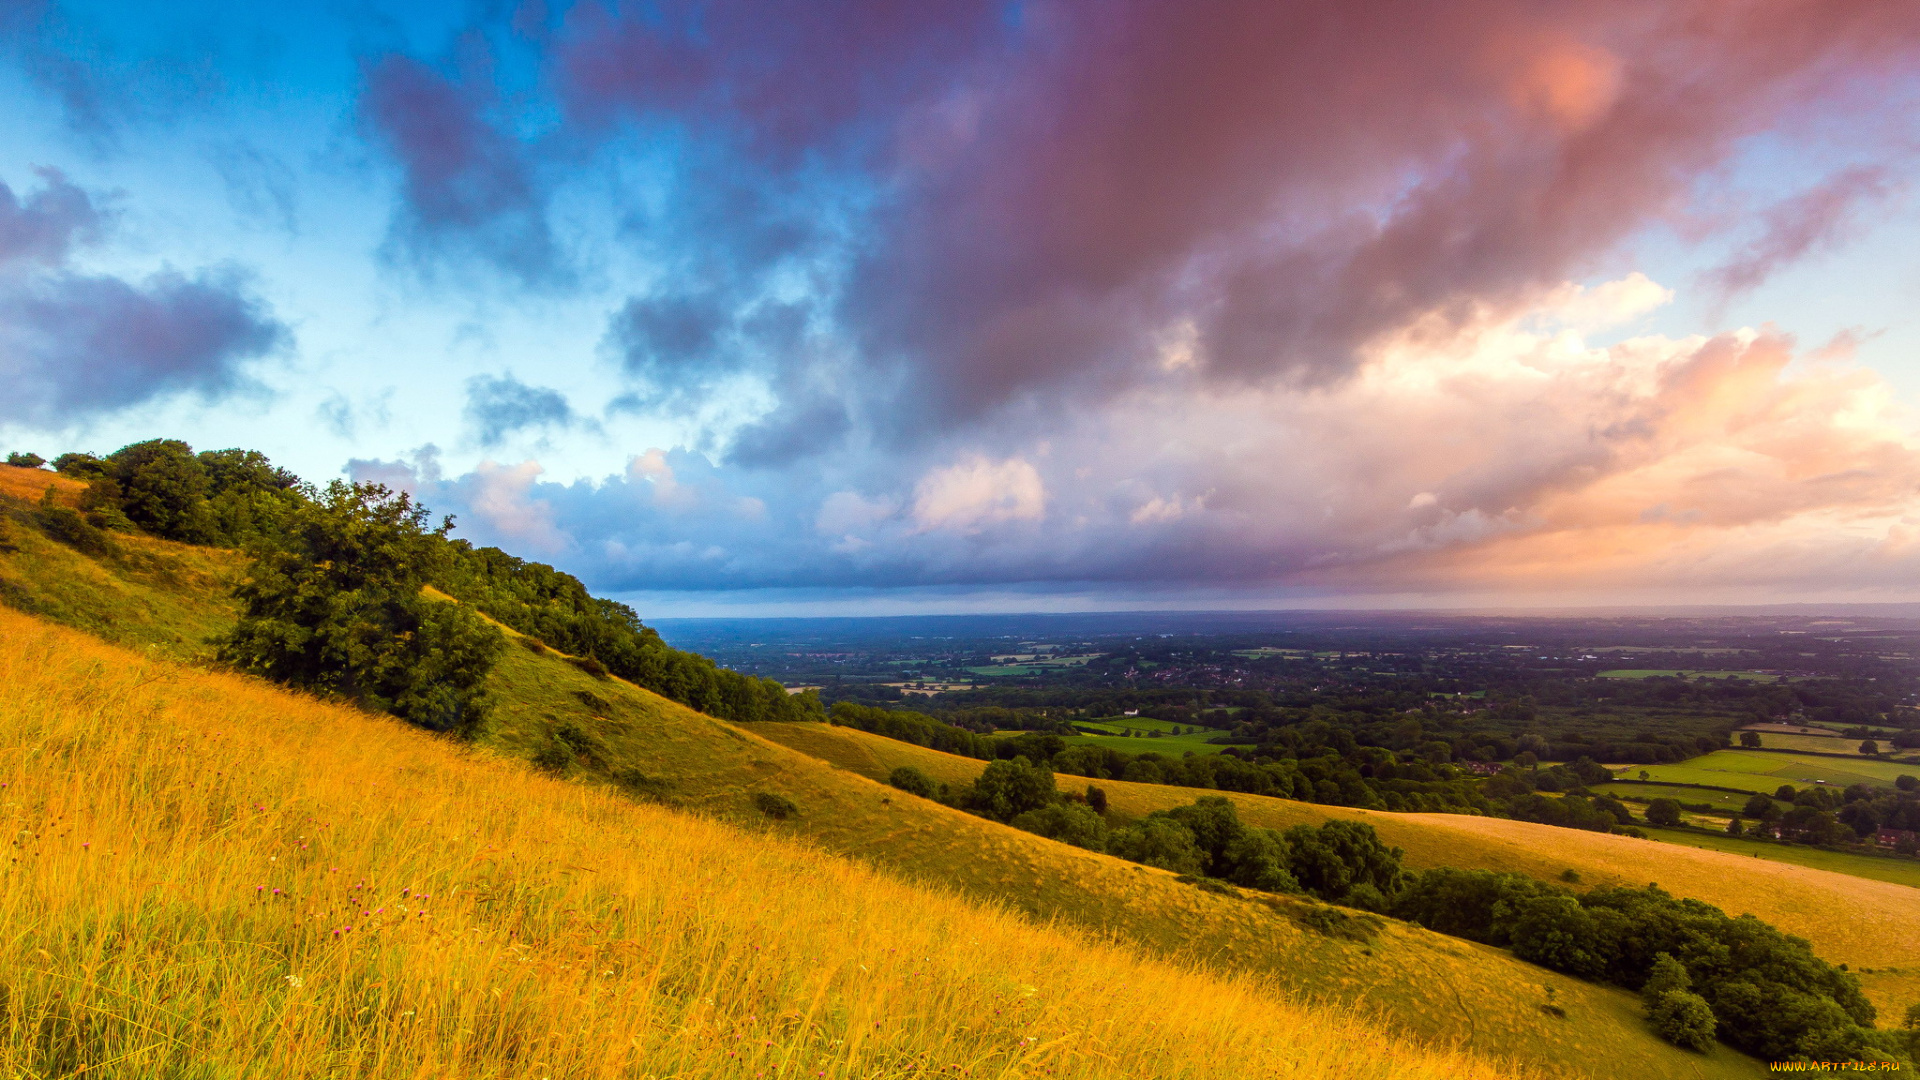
[10,438,822,732]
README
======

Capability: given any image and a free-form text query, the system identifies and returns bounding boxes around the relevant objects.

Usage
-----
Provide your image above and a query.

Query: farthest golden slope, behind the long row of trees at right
[756,724,1920,1026]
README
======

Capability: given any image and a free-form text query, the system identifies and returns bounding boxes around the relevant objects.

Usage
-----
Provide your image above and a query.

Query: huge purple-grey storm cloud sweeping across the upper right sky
[529,0,1920,432]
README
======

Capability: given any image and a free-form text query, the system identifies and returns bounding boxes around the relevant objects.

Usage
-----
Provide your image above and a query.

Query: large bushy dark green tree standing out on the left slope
[221,480,505,732]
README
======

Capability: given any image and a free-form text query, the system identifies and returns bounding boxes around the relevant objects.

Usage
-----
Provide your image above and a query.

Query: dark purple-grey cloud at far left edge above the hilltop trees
[0,171,288,425]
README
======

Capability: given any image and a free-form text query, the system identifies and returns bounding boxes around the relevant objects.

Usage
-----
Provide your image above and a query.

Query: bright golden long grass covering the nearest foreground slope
[0,611,1530,1080]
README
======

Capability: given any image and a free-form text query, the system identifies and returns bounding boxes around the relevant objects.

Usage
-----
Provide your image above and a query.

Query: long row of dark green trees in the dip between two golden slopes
[889,757,1914,1061]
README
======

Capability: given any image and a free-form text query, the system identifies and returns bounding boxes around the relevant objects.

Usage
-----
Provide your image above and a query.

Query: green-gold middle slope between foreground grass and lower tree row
[486,648,1759,1078]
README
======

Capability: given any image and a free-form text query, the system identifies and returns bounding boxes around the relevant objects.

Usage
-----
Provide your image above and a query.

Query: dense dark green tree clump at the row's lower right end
[1390,869,1910,1061]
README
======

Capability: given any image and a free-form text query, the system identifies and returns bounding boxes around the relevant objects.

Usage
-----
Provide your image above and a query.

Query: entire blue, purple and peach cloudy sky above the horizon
[0,0,1920,617]
